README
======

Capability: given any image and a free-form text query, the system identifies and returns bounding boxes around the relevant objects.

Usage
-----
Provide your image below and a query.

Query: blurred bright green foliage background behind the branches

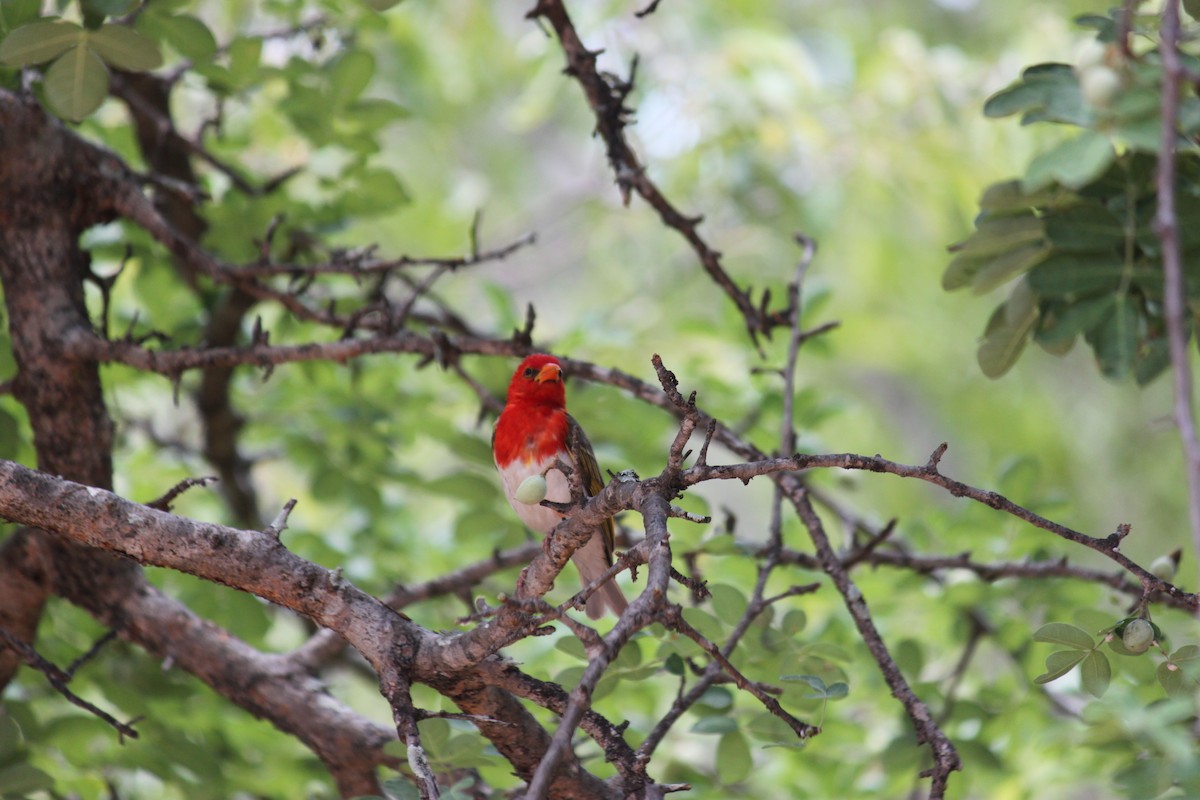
[0,0,1198,800]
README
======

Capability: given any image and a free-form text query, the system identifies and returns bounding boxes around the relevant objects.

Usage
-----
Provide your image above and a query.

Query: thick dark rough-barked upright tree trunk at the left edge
[0,89,139,685]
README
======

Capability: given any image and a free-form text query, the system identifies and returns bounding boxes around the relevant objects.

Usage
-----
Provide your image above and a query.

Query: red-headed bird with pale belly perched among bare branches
[492,353,629,619]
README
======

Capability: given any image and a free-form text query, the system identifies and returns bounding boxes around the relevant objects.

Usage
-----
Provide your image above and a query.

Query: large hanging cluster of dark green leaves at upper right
[942,11,1200,385]
